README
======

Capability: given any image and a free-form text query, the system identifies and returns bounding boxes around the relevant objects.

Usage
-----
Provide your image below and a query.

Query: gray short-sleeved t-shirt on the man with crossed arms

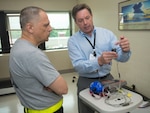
[9,39,63,109]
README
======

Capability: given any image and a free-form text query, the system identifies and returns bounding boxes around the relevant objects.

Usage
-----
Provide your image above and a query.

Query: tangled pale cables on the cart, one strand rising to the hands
[90,62,131,107]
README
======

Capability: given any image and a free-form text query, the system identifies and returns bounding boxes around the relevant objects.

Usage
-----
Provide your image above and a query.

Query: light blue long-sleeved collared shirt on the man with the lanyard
[68,27,131,78]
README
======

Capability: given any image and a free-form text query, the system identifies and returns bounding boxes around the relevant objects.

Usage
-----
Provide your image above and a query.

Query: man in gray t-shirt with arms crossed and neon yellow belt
[9,6,68,113]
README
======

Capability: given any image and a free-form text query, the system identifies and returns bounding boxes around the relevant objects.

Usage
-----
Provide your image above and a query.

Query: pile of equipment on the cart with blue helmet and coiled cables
[89,80,132,107]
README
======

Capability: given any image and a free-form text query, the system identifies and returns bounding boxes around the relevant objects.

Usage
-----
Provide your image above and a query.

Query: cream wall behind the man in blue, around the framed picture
[79,0,150,98]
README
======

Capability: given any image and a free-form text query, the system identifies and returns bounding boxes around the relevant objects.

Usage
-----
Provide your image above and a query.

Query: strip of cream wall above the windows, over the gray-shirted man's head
[0,0,76,11]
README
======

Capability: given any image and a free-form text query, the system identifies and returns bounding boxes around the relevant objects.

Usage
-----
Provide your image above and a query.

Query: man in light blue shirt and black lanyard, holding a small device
[68,4,131,113]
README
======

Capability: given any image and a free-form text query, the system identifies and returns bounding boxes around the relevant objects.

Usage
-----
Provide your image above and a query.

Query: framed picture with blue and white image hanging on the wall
[118,0,150,30]
